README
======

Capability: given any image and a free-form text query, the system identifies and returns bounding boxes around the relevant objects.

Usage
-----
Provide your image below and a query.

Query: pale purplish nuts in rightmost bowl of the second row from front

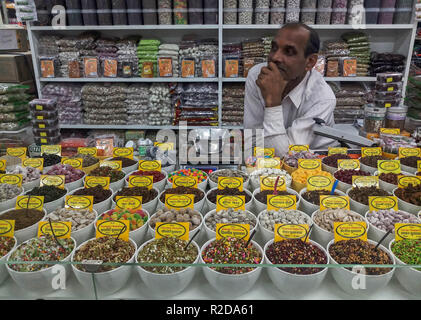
[367,210,420,232]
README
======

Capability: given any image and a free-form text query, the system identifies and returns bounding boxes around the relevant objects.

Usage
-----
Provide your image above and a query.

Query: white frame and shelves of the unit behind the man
[28,0,417,130]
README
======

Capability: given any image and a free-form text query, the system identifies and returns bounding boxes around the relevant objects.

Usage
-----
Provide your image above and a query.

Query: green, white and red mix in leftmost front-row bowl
[9,235,75,272]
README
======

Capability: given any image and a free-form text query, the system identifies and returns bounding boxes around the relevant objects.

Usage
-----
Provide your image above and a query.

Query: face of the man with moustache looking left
[268,28,310,81]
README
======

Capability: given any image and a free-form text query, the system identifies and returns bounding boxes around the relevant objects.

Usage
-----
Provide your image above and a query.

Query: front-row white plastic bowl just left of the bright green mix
[327,239,396,296]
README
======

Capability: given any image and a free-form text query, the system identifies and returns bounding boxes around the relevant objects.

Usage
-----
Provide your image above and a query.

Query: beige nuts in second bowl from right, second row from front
[313,209,364,232]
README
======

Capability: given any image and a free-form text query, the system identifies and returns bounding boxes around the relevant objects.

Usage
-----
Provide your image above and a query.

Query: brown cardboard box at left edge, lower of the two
[0,53,33,83]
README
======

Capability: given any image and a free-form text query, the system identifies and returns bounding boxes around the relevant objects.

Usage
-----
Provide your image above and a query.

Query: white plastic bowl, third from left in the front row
[136,239,200,297]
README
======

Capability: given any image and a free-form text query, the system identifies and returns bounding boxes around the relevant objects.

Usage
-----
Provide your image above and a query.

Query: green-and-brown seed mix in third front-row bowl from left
[137,237,198,274]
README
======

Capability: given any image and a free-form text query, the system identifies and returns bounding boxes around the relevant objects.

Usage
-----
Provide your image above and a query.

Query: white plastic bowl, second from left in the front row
[71,239,137,296]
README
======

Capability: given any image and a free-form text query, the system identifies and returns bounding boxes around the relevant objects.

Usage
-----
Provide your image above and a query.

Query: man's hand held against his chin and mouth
[256,62,288,108]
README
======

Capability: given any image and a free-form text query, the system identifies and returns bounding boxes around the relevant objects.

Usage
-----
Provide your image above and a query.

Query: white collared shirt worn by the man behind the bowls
[244,63,337,157]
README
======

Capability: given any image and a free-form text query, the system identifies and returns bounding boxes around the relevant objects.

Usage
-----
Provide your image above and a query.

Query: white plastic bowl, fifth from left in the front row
[264,239,329,296]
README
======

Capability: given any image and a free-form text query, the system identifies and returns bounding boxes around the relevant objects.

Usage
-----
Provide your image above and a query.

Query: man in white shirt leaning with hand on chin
[244,23,336,157]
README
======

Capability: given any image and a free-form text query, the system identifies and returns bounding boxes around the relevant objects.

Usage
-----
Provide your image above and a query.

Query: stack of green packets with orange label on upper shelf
[137,39,161,78]
